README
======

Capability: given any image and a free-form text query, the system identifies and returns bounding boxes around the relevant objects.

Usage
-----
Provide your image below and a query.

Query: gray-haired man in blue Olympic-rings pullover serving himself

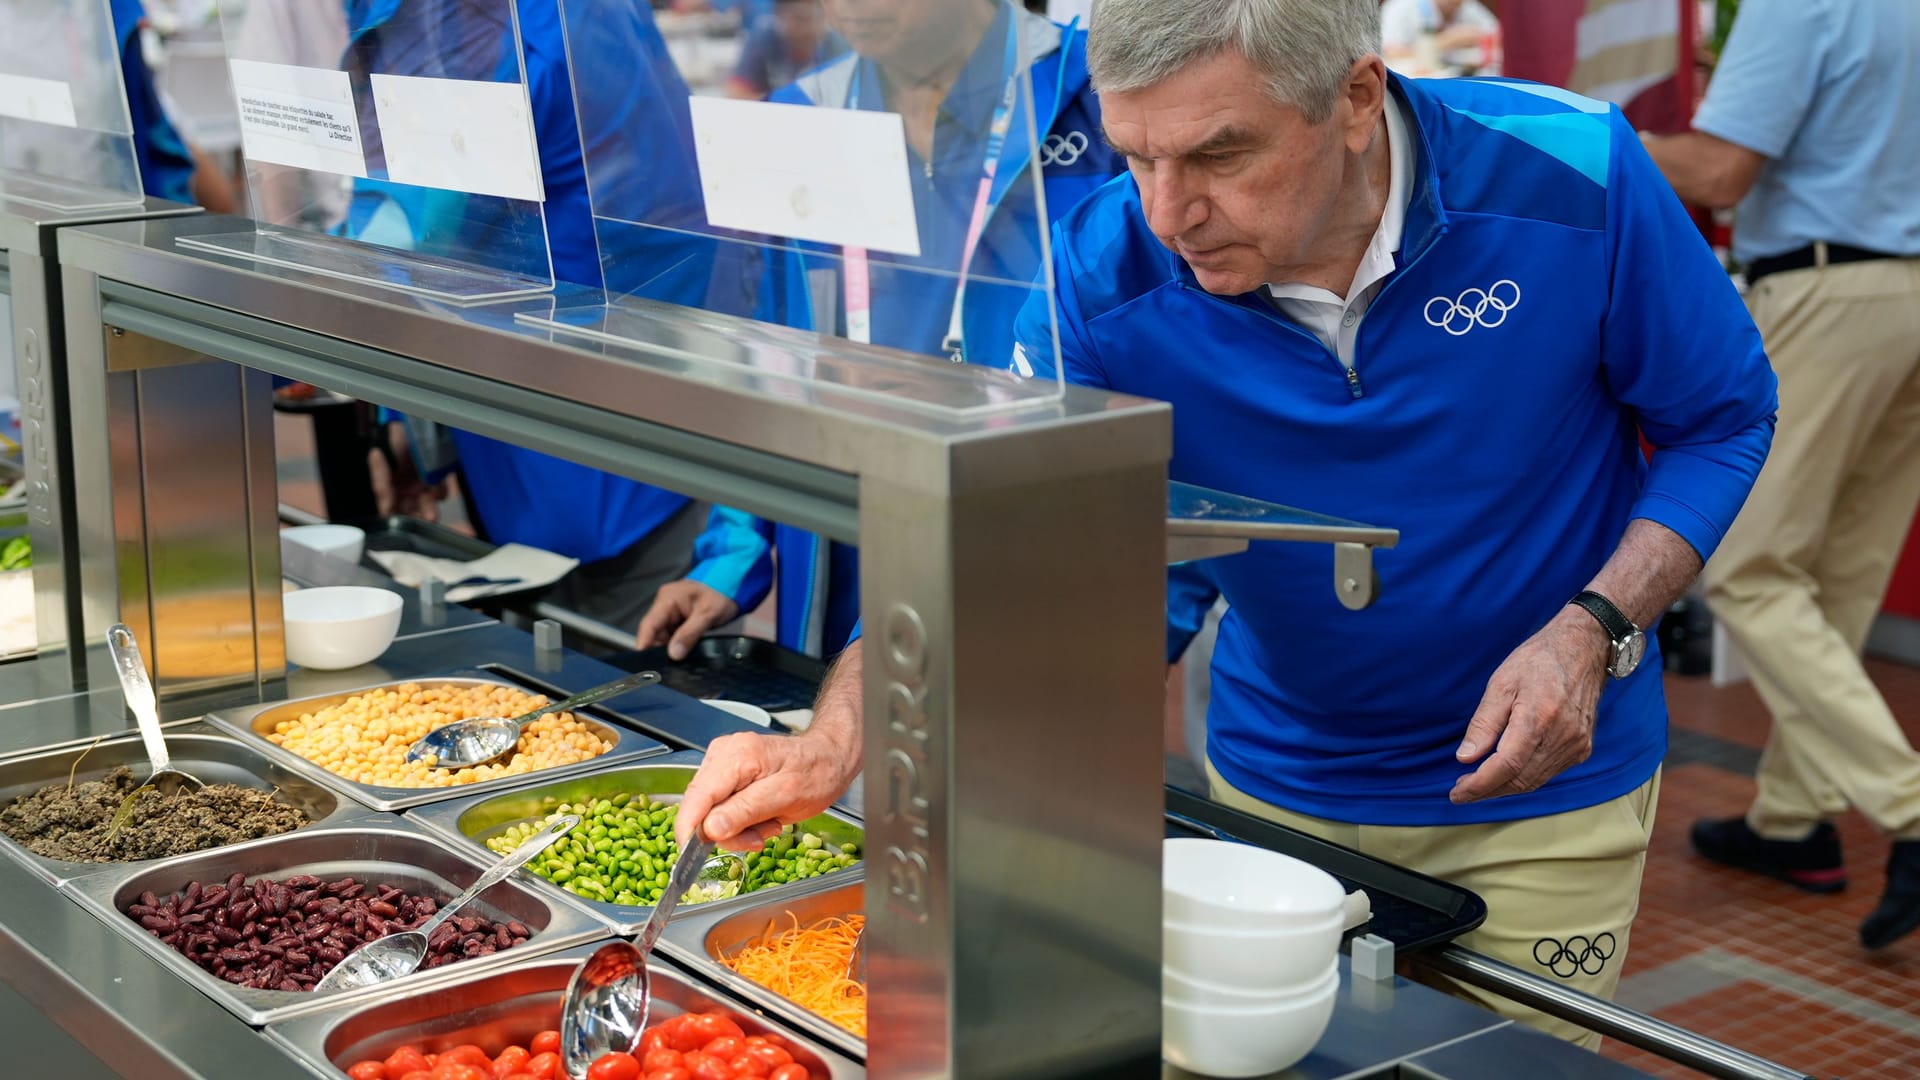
[680,0,1776,1043]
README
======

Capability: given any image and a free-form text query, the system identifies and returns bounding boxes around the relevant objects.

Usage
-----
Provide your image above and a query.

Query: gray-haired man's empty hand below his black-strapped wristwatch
[1450,607,1609,803]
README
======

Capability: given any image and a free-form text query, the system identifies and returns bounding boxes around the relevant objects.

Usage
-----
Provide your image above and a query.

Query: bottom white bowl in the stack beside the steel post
[1160,974,1340,1076]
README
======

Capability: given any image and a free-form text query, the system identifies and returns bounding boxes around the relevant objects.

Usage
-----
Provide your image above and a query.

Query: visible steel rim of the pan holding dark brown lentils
[0,723,371,886]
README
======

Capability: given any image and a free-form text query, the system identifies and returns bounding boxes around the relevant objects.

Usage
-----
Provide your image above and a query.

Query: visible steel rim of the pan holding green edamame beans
[407,749,866,934]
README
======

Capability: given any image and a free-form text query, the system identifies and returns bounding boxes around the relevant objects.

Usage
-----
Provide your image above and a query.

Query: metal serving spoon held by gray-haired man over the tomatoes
[561,828,729,1076]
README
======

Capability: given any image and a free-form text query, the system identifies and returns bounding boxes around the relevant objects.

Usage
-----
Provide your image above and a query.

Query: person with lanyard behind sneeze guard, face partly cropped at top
[636,0,1123,659]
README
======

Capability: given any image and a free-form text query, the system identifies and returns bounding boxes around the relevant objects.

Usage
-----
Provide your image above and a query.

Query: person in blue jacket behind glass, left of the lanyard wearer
[346,0,712,626]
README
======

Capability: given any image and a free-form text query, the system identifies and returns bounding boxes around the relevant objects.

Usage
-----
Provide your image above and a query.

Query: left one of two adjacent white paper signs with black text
[227,60,367,177]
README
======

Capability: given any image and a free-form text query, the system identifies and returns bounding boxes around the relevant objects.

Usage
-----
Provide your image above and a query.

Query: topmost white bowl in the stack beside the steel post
[1160,838,1346,930]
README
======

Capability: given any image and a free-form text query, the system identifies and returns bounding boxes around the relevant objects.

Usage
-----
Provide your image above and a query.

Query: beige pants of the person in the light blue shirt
[1705,259,1920,840]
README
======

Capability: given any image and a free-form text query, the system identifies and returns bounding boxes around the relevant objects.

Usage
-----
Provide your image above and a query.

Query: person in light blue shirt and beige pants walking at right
[1651,0,1920,947]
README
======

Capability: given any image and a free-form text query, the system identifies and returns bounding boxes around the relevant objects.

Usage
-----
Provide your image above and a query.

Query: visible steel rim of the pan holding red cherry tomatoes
[267,945,866,1080]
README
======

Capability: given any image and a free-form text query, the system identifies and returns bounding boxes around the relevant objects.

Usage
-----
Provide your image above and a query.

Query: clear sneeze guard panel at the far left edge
[0,0,142,213]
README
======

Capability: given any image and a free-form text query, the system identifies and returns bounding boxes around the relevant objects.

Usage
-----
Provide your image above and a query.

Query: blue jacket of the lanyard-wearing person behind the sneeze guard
[689,4,1125,653]
